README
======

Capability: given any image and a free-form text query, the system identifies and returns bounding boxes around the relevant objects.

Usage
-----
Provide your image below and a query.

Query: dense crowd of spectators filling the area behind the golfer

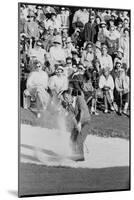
[19,4,131,115]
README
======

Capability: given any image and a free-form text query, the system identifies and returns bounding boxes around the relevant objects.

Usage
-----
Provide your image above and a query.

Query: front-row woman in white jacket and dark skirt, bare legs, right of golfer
[99,67,114,113]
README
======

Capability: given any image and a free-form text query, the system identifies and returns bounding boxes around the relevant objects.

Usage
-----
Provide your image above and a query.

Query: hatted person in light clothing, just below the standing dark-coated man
[81,42,94,69]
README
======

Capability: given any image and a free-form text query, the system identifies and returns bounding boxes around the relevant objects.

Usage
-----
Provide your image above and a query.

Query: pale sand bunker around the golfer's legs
[20,125,129,168]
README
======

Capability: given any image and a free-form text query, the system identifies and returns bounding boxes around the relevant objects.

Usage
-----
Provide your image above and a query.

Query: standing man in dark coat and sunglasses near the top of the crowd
[84,15,96,43]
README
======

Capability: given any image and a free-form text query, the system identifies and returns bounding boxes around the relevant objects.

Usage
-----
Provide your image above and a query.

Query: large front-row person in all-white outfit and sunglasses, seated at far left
[26,60,49,114]
